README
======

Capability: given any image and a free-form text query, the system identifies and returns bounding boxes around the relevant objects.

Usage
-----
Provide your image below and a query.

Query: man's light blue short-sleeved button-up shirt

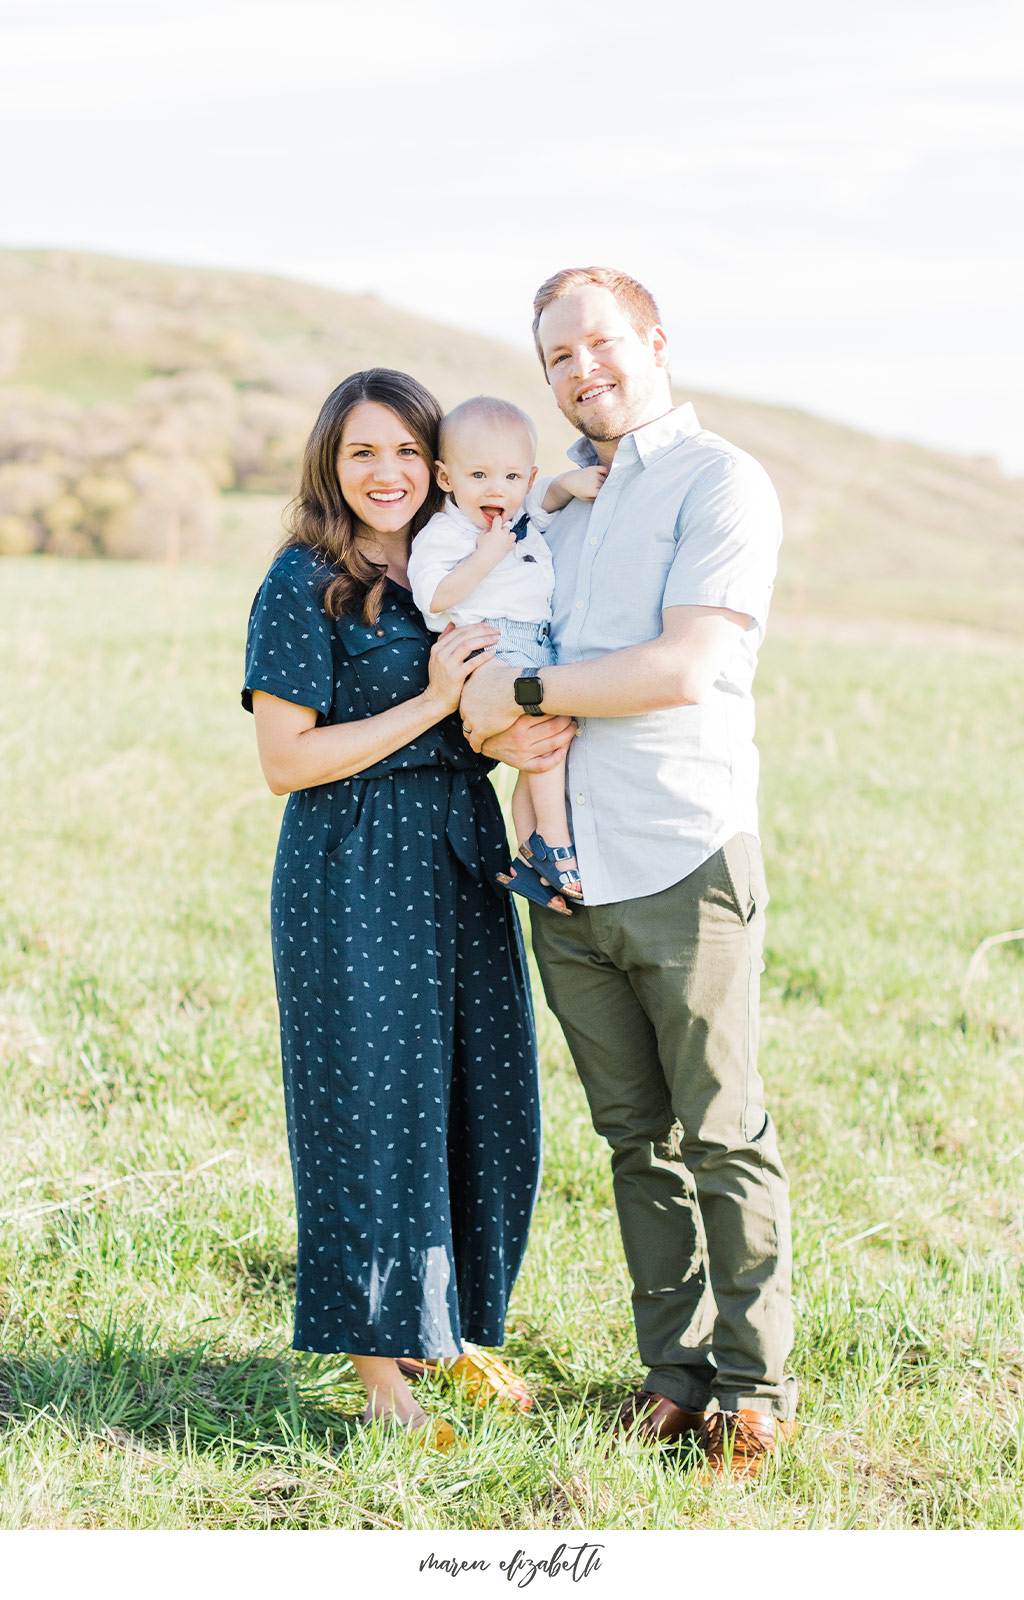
[538,405,782,906]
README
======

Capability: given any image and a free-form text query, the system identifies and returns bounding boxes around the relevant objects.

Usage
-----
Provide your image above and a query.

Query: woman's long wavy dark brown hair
[282,366,445,627]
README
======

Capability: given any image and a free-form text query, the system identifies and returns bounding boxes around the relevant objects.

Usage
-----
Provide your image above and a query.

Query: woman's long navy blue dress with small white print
[242,547,541,1357]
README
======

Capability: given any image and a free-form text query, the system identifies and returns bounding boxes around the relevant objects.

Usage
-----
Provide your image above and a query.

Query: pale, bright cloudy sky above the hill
[0,0,1024,474]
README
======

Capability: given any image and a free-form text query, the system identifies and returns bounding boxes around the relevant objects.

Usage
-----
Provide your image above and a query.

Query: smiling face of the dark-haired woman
[338,400,432,536]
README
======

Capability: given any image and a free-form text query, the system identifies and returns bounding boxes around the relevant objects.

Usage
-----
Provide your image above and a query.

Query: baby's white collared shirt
[408,478,555,634]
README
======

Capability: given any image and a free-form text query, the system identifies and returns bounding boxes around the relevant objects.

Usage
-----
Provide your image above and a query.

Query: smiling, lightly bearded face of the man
[538,283,672,440]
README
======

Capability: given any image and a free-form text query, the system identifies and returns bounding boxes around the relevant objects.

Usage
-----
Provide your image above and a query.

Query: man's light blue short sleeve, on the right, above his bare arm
[662,453,782,627]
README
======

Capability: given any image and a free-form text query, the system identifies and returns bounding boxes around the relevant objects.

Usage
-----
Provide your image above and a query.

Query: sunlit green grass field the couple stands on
[0,562,1024,1530]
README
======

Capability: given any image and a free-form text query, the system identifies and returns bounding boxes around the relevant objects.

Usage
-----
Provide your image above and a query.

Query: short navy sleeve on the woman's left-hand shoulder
[242,547,334,717]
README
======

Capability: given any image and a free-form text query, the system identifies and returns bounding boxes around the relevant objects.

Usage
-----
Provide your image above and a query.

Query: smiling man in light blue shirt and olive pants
[462,267,797,1477]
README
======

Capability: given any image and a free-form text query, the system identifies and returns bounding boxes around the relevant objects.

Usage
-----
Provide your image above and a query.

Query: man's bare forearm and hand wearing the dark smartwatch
[461,605,750,749]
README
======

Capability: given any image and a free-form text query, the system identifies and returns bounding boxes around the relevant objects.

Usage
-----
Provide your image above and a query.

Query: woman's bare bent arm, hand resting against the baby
[253,622,498,795]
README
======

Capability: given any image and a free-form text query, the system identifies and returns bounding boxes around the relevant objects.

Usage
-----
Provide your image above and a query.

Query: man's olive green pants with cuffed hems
[531,834,797,1419]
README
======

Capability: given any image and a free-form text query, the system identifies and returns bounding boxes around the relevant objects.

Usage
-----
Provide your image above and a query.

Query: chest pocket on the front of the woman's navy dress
[334,613,430,722]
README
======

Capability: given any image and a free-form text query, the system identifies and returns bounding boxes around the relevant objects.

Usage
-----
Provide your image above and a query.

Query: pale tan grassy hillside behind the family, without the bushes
[0,250,1024,632]
